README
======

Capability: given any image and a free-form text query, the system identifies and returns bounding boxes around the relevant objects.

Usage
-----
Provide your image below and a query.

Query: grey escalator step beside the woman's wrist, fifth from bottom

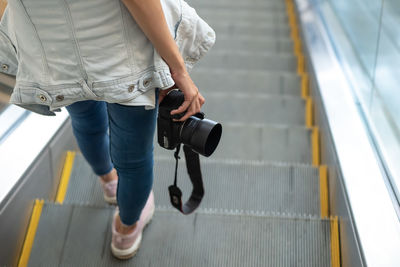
[191,67,301,96]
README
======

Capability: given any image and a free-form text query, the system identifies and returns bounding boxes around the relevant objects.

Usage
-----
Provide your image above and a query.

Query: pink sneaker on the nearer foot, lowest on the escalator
[111,191,155,260]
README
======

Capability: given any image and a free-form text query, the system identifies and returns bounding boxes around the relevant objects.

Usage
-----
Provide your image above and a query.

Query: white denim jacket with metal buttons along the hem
[0,0,215,115]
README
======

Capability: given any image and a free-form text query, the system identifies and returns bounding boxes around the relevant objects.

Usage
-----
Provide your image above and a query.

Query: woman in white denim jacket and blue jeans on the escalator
[0,0,215,259]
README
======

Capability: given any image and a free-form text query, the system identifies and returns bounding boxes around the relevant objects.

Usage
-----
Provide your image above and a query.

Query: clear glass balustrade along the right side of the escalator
[314,0,400,201]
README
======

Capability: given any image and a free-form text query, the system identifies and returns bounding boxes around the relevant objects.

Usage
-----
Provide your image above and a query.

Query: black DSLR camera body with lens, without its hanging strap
[157,90,222,157]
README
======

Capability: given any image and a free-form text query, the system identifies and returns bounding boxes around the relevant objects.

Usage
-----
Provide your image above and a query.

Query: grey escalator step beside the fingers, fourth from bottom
[202,92,305,125]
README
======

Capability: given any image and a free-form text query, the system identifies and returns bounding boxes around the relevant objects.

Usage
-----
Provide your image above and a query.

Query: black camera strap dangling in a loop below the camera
[168,144,204,214]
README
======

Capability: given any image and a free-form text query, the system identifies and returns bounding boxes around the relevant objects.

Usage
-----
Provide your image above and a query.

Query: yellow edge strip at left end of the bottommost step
[18,199,44,267]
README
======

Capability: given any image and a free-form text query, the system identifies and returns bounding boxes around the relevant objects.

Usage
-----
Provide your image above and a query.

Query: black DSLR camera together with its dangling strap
[157,90,222,214]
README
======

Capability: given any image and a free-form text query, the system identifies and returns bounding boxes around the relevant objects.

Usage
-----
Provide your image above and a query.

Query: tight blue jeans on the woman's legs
[67,99,158,225]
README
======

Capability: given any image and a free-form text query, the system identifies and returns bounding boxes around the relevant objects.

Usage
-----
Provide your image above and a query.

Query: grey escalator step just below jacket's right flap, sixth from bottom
[198,51,297,72]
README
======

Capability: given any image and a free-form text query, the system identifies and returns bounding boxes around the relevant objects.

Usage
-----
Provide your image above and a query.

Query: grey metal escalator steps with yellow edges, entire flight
[20,0,340,267]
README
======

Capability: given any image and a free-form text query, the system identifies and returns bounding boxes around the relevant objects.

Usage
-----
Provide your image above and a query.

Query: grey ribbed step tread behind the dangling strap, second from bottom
[64,154,320,216]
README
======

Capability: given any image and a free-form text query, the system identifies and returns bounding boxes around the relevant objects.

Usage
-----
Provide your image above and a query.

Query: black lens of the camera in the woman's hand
[180,116,222,157]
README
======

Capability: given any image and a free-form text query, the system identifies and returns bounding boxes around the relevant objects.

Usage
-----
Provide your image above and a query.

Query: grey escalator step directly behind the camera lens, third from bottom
[155,124,312,164]
